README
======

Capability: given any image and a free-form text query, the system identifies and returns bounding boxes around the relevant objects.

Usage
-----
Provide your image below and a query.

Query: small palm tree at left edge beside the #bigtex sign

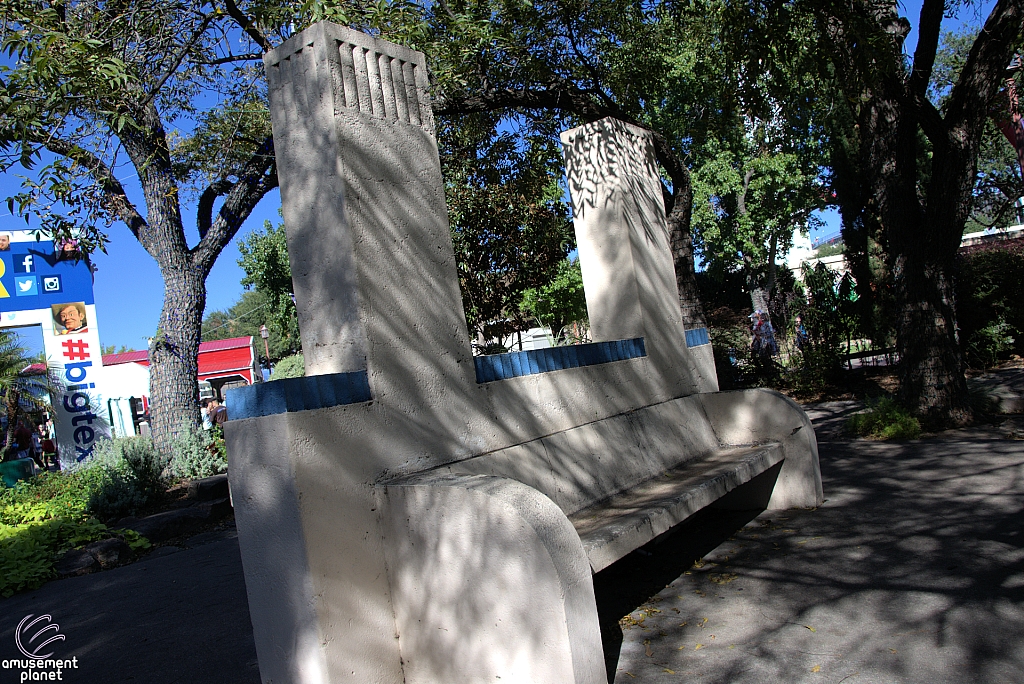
[0,330,60,461]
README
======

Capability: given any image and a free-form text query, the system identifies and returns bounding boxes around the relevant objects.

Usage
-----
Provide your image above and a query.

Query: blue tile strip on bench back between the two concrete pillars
[473,337,647,385]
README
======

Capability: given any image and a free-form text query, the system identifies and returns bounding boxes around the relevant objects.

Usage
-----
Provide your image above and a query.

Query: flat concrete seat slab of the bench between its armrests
[569,443,784,572]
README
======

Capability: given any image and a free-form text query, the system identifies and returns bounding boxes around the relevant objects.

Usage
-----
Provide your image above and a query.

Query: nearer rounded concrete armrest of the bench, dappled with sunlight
[380,473,606,684]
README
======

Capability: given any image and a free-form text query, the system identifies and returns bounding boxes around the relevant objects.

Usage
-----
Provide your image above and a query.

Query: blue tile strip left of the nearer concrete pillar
[226,371,373,421]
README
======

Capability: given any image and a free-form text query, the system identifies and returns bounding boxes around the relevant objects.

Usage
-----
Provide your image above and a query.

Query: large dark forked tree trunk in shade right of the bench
[809,0,1024,425]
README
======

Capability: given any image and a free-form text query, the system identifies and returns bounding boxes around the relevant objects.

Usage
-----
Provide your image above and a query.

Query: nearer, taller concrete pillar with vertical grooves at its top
[264,23,473,400]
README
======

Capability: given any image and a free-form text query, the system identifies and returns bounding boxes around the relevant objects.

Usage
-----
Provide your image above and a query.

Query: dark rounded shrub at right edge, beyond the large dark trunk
[956,242,1024,368]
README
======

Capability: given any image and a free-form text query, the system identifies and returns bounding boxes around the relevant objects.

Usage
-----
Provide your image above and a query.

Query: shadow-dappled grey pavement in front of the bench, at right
[595,429,1024,684]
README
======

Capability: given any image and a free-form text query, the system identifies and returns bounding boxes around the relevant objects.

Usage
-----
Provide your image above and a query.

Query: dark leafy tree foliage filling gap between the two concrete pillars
[438,117,574,348]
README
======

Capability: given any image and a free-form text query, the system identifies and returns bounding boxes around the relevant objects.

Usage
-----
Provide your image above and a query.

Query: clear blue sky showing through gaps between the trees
[0,0,994,358]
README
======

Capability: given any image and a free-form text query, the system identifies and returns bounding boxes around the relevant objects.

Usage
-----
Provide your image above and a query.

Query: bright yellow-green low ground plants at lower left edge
[0,464,150,597]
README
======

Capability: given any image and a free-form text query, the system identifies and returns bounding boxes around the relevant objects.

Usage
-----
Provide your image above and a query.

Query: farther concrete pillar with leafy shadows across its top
[561,118,718,392]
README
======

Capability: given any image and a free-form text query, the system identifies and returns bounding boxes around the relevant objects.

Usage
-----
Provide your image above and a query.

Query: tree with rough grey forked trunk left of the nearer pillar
[0,0,419,447]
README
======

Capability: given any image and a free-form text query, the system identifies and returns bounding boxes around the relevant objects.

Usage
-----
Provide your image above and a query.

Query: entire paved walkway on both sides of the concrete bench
[0,413,1024,684]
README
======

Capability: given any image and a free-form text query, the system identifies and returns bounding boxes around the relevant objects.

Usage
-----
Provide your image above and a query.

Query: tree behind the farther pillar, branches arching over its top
[426,0,733,328]
